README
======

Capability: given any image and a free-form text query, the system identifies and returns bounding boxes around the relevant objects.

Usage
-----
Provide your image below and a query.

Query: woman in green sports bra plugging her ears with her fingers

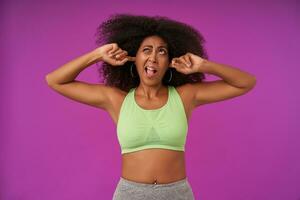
[46,14,256,200]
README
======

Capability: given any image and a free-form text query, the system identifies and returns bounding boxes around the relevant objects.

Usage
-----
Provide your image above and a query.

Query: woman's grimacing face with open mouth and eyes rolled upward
[135,36,169,84]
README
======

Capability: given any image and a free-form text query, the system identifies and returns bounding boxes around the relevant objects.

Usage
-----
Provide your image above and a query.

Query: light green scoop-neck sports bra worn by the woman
[117,86,188,154]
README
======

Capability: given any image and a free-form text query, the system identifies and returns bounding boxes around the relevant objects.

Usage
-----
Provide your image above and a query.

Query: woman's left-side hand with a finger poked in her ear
[95,43,135,66]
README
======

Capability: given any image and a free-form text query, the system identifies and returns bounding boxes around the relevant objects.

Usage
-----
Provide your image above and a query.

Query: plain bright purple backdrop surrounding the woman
[0,0,300,200]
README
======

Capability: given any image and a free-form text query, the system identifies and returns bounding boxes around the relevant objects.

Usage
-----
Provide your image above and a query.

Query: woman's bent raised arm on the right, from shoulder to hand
[171,53,256,108]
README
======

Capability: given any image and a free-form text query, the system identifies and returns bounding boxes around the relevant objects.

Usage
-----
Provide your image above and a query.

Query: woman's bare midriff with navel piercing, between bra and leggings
[122,148,186,184]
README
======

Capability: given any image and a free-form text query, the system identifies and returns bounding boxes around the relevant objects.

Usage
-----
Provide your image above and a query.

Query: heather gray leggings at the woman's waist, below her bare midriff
[113,177,195,200]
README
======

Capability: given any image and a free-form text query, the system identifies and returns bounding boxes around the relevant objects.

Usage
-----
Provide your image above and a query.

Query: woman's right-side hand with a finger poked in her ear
[170,52,206,74]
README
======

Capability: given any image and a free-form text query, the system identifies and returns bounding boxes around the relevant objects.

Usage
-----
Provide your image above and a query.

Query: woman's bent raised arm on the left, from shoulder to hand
[46,43,130,110]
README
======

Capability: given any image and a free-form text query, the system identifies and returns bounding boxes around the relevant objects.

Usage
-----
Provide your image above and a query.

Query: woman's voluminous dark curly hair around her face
[95,14,208,92]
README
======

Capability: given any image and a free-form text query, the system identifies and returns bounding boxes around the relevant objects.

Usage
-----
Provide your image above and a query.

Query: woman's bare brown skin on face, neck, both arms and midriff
[46,36,256,184]
